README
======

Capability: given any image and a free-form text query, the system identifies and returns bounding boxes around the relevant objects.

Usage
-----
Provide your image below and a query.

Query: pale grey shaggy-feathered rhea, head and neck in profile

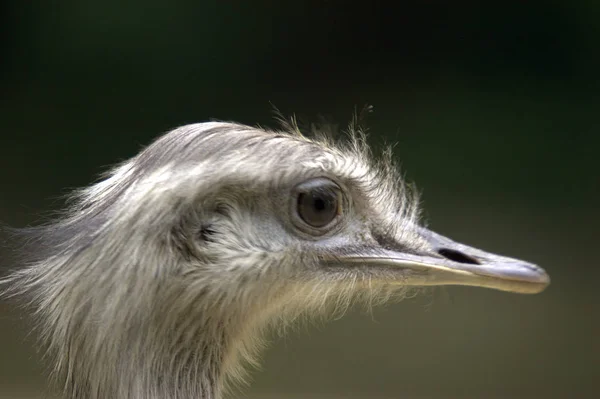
[0,119,550,399]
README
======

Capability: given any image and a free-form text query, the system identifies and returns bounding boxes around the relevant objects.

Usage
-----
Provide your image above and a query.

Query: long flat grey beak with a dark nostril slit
[324,227,550,294]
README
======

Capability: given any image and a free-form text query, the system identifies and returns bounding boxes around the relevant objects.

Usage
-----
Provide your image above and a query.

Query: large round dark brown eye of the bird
[295,178,342,229]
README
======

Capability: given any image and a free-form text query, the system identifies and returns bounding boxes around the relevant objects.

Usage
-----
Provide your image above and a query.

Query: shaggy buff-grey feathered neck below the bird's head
[48,258,290,399]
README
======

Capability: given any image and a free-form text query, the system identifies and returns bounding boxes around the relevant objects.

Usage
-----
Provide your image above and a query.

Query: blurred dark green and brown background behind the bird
[0,0,600,399]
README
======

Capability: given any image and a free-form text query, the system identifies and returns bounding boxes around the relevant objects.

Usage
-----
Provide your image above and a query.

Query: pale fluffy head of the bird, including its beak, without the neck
[127,123,549,303]
